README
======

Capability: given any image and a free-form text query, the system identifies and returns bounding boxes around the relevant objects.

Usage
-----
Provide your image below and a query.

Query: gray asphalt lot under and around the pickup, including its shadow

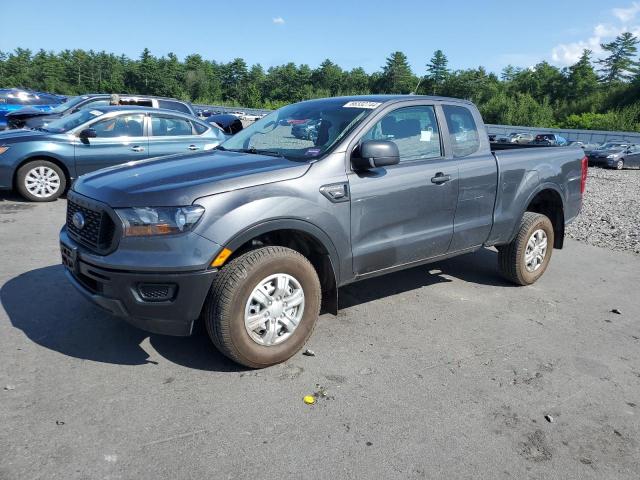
[0,193,640,480]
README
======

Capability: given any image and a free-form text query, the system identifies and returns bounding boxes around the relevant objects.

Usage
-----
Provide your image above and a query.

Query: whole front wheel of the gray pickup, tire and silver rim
[203,247,321,368]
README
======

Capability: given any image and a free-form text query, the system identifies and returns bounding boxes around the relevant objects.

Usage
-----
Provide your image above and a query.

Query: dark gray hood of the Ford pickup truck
[73,150,310,207]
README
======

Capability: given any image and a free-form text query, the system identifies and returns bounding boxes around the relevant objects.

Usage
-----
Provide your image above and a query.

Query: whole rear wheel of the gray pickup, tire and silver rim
[498,212,554,285]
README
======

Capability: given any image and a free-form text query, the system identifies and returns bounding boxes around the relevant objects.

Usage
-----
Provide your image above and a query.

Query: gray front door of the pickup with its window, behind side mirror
[348,105,458,275]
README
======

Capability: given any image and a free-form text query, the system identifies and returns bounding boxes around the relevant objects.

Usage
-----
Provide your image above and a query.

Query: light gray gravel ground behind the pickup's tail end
[567,168,640,255]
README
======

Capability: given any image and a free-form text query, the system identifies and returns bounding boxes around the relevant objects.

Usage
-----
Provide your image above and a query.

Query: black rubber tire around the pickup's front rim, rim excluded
[203,247,321,368]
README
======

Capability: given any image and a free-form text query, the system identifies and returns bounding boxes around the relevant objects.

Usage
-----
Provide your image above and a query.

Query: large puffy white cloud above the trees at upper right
[551,2,640,65]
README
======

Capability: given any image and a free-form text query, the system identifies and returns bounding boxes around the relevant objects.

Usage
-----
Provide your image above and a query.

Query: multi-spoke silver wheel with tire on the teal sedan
[16,160,67,202]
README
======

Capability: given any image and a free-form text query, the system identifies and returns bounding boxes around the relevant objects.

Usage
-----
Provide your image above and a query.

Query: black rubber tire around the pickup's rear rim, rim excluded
[498,212,554,285]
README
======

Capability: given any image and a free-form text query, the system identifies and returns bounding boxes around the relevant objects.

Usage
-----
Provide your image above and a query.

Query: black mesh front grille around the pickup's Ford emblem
[67,199,115,252]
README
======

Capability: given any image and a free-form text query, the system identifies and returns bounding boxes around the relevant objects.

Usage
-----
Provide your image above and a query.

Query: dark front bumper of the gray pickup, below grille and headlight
[60,231,217,336]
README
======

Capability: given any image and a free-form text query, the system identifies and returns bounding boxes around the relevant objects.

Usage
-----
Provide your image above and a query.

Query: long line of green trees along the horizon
[0,32,640,131]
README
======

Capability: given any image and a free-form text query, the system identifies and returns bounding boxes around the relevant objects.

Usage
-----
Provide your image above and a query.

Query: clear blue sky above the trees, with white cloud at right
[0,0,640,74]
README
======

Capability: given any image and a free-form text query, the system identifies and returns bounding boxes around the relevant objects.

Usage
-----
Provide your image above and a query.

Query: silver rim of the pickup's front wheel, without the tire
[244,273,304,347]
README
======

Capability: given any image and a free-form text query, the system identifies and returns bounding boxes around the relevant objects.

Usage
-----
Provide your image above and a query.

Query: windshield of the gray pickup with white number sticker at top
[221,98,380,160]
